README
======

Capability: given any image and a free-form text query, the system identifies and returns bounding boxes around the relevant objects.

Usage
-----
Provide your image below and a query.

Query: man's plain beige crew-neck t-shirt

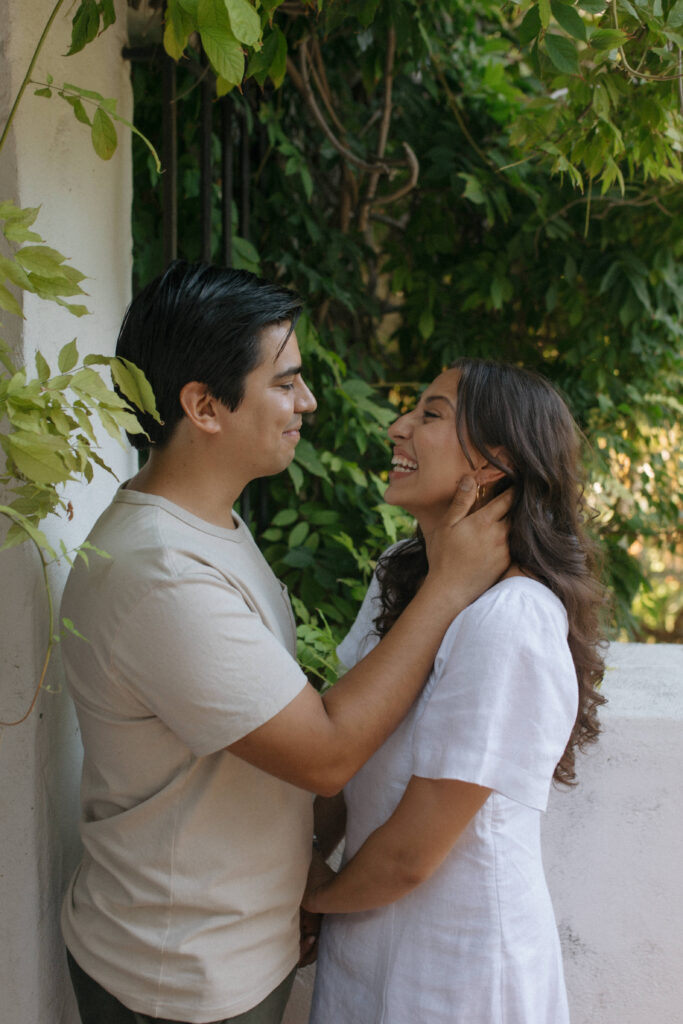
[62,488,311,1022]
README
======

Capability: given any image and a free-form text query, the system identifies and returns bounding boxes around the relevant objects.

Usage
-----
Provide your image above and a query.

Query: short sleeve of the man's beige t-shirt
[112,573,306,756]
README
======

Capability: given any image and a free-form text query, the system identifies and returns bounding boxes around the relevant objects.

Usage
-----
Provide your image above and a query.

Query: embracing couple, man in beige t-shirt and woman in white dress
[62,262,601,1024]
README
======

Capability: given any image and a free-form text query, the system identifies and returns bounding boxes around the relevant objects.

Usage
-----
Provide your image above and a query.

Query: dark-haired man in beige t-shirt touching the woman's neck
[62,262,508,1024]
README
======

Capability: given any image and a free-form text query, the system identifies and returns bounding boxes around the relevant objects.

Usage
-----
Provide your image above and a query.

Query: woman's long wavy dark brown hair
[375,358,605,784]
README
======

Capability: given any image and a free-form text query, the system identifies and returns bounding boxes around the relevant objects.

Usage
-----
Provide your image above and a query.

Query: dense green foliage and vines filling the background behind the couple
[129,0,683,671]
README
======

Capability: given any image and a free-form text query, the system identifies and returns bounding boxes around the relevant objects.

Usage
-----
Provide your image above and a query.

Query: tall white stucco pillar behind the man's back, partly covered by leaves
[0,0,133,1024]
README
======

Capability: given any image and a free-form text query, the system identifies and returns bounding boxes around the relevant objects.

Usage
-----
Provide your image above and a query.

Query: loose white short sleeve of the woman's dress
[413,578,578,810]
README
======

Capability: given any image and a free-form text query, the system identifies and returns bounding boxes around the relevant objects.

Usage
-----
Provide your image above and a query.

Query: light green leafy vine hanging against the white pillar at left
[0,0,161,726]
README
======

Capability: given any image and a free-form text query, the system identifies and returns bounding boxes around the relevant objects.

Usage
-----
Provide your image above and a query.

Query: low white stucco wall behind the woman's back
[284,644,683,1024]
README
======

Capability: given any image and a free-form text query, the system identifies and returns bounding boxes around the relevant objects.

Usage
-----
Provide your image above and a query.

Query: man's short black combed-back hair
[116,260,302,449]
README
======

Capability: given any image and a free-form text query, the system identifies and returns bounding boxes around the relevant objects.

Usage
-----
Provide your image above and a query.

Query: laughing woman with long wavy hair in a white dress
[304,359,604,1024]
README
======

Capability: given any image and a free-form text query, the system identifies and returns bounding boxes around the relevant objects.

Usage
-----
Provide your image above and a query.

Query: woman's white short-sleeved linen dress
[310,577,578,1024]
